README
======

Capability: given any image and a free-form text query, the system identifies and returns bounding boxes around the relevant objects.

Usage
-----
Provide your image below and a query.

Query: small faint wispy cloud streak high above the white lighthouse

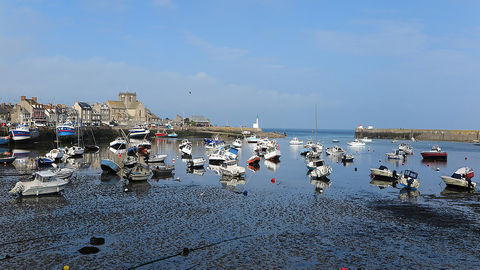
[185,32,248,60]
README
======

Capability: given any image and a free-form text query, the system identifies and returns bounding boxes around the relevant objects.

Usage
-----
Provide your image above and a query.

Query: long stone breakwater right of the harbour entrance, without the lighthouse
[355,128,480,142]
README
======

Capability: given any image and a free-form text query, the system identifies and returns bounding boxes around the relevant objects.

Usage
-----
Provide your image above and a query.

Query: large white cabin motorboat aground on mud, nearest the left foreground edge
[9,171,68,196]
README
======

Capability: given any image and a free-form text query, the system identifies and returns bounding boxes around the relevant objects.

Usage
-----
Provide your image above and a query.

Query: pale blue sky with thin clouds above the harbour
[0,0,480,129]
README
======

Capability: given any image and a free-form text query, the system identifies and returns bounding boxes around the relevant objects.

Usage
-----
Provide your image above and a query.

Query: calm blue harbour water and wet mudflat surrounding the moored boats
[0,130,480,269]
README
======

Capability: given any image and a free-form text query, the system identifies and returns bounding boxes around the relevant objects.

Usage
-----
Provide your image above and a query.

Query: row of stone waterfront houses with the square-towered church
[0,92,210,126]
